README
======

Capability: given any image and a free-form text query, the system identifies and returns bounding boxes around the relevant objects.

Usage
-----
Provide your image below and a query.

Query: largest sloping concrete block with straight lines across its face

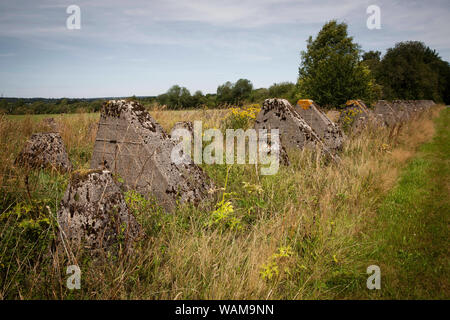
[91,100,212,211]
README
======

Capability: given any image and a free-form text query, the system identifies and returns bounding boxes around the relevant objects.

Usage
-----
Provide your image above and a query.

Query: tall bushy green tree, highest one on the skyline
[297,20,376,107]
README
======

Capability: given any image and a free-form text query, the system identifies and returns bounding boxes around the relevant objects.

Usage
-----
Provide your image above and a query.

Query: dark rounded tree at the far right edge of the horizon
[377,41,450,103]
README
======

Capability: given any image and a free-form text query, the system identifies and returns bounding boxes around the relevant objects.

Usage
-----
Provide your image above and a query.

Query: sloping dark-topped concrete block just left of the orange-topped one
[255,99,337,160]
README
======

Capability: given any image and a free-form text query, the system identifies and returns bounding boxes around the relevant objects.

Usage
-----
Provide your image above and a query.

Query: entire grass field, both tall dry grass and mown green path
[0,107,450,299]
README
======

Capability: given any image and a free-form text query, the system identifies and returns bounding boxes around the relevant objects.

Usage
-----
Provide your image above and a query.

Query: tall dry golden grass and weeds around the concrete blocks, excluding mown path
[0,108,440,299]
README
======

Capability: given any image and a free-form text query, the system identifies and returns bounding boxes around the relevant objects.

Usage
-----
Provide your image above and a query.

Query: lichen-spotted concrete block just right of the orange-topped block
[338,100,374,132]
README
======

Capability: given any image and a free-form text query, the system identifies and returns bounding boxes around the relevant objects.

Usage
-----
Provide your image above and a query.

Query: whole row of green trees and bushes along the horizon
[0,20,450,114]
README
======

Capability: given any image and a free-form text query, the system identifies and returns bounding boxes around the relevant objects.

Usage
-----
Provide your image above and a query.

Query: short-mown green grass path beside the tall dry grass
[359,108,450,299]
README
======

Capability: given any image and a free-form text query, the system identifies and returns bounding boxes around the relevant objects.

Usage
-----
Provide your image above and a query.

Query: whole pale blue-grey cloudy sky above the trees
[0,0,450,98]
